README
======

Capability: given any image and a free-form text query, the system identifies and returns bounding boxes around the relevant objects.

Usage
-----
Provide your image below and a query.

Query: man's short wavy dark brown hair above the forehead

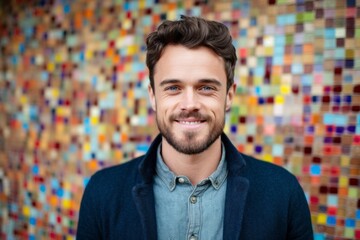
[146,16,237,90]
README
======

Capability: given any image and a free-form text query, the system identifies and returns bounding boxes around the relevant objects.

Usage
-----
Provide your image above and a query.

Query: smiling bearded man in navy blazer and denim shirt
[77,17,313,240]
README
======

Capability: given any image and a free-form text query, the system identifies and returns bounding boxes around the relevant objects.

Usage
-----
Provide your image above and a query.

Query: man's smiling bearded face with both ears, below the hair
[149,45,235,154]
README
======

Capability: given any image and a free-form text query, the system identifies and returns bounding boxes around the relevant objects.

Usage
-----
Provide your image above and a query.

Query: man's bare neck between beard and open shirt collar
[161,137,221,185]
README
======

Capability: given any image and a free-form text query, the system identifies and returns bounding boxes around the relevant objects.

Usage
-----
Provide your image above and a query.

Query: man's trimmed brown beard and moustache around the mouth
[156,112,225,155]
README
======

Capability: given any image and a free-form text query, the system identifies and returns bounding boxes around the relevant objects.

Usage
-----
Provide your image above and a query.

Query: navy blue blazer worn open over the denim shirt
[77,134,313,240]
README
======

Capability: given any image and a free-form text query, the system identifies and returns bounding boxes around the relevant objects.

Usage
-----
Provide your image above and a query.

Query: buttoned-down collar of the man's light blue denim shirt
[156,143,228,191]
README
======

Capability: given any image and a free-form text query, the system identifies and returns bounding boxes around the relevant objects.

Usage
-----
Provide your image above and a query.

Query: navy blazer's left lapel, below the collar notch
[132,183,157,240]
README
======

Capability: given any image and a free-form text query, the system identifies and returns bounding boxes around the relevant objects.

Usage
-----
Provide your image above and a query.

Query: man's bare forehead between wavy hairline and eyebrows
[154,45,226,84]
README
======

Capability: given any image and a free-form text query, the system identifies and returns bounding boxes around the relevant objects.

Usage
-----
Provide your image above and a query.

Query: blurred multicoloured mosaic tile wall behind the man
[0,0,360,240]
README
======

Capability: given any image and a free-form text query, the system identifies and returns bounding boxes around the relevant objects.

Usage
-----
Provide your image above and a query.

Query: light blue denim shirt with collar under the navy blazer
[154,144,227,240]
